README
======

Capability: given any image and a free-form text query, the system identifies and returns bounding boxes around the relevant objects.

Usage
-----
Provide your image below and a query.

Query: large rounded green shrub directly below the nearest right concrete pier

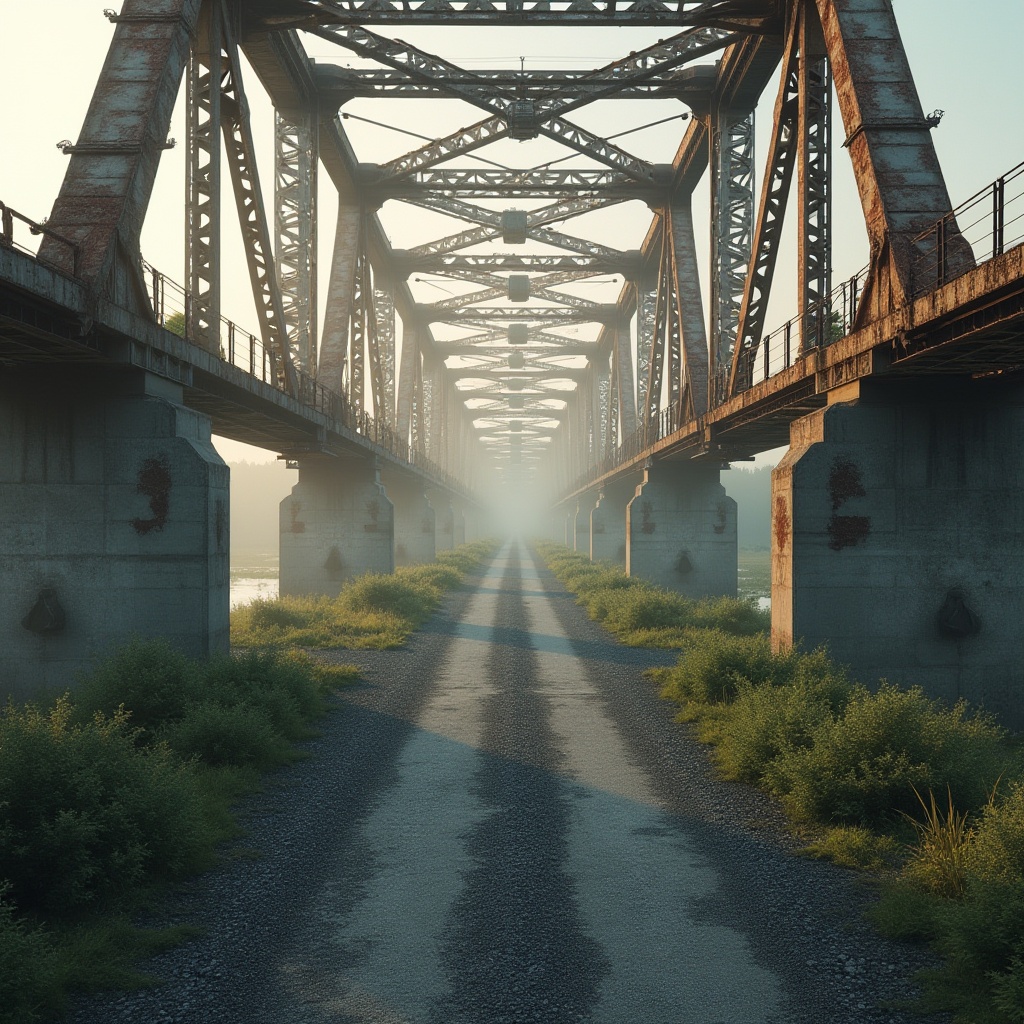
[765,681,1002,826]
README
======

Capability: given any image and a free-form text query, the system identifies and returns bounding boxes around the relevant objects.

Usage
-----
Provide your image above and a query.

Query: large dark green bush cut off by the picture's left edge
[0,696,207,919]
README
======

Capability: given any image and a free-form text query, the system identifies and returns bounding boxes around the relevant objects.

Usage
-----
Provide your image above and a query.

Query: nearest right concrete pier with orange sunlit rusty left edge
[772,381,1024,729]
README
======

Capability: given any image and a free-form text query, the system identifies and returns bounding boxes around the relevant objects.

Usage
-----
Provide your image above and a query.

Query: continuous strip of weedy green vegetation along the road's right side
[540,544,1024,1024]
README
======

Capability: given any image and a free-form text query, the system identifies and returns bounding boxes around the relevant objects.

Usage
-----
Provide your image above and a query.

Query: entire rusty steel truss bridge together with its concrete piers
[0,0,1024,723]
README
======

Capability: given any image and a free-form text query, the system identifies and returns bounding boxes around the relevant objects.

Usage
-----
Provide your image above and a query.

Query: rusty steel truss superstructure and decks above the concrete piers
[0,0,1024,501]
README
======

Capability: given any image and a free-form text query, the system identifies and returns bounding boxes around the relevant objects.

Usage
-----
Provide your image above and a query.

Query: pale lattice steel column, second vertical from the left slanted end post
[274,111,319,376]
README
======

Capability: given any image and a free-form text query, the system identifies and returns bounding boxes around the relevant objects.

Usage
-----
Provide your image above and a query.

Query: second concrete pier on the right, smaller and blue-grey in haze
[626,462,736,598]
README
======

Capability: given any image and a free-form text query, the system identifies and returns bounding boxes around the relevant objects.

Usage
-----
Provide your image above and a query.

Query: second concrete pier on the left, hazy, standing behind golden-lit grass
[281,457,394,597]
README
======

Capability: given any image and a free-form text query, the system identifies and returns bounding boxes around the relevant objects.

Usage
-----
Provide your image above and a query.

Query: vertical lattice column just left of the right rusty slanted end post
[797,2,831,352]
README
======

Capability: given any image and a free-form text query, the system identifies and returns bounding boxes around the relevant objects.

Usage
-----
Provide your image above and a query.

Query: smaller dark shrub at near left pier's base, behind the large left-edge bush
[75,637,202,741]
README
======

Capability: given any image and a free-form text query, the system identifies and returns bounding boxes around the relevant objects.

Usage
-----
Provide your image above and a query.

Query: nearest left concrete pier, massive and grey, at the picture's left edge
[0,368,229,699]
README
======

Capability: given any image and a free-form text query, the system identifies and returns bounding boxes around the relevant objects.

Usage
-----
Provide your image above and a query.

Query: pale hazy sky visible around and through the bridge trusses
[0,0,1024,459]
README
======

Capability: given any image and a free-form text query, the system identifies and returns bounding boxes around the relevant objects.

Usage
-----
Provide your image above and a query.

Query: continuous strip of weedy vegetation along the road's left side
[0,543,494,1024]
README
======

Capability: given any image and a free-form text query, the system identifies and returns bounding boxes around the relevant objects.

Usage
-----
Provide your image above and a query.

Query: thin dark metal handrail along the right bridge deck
[568,161,1024,494]
